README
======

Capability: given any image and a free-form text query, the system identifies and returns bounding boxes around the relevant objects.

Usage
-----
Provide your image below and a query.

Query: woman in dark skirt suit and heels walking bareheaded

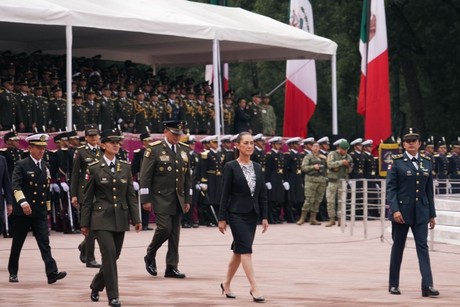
[219,132,268,302]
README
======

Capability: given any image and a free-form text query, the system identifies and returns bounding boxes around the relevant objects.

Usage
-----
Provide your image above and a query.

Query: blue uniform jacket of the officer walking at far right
[386,153,436,225]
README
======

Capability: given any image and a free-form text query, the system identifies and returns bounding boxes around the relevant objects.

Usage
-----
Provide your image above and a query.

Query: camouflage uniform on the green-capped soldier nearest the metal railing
[326,150,353,221]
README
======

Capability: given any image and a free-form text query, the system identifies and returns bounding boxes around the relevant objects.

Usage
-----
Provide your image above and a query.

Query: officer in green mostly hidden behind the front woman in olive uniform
[70,124,102,268]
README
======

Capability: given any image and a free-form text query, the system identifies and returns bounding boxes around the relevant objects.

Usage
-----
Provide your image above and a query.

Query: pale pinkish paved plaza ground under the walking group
[0,221,460,307]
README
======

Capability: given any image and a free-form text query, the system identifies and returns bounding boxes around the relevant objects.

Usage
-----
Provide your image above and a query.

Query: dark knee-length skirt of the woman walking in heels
[228,211,258,254]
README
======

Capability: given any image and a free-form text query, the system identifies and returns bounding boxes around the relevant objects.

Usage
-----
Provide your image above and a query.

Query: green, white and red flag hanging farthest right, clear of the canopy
[357,0,391,146]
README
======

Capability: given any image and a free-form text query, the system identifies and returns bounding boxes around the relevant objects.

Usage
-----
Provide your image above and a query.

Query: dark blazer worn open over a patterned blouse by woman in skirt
[219,160,268,221]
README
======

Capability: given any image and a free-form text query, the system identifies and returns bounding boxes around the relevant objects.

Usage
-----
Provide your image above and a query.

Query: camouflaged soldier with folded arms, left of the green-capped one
[297,142,327,225]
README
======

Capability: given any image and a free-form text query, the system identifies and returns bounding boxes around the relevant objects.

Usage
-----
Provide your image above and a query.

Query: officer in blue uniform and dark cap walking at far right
[386,128,439,296]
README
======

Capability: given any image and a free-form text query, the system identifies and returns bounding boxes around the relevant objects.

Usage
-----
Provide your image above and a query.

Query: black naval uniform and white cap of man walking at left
[8,134,66,284]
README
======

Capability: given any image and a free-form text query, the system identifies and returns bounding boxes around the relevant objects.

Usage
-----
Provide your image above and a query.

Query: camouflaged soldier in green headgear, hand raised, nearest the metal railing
[326,139,353,227]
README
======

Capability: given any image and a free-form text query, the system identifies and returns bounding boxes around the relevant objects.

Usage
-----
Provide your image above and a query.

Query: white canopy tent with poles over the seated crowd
[0,0,337,133]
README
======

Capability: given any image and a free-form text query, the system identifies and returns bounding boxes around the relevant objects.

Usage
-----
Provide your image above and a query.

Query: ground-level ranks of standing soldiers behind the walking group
[0,125,460,236]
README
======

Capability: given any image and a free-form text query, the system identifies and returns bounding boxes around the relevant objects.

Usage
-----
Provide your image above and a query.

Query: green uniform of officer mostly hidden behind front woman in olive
[70,145,102,263]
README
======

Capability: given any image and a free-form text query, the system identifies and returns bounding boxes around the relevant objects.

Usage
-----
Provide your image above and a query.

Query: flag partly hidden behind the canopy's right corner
[283,0,317,137]
